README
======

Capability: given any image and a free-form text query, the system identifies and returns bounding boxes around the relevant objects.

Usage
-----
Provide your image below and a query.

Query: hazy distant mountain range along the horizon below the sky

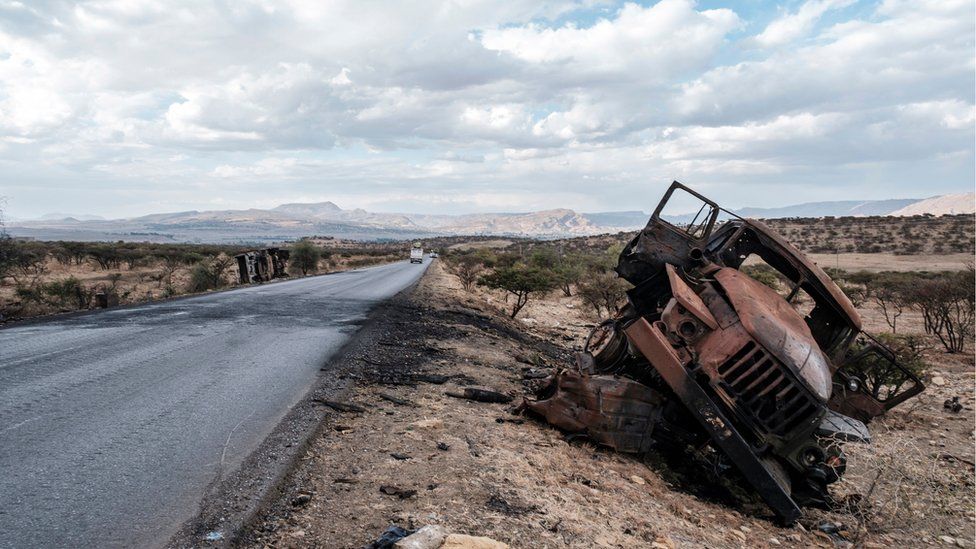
[7,193,976,243]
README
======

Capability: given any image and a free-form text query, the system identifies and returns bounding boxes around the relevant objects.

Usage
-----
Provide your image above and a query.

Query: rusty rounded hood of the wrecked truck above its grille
[715,267,831,402]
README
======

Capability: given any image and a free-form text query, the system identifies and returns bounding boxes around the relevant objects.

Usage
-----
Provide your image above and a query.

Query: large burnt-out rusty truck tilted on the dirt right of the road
[524,181,924,523]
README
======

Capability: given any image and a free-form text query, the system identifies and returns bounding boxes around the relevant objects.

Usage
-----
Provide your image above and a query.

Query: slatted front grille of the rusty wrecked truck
[718,341,820,436]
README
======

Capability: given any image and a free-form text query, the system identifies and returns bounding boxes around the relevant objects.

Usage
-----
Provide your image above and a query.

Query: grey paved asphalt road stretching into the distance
[0,261,428,547]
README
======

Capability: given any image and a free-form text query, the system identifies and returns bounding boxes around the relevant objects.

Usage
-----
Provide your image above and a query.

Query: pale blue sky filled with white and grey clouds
[0,0,976,219]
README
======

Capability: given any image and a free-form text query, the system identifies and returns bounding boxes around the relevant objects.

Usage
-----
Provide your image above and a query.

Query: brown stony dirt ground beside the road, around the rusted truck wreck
[243,262,976,548]
